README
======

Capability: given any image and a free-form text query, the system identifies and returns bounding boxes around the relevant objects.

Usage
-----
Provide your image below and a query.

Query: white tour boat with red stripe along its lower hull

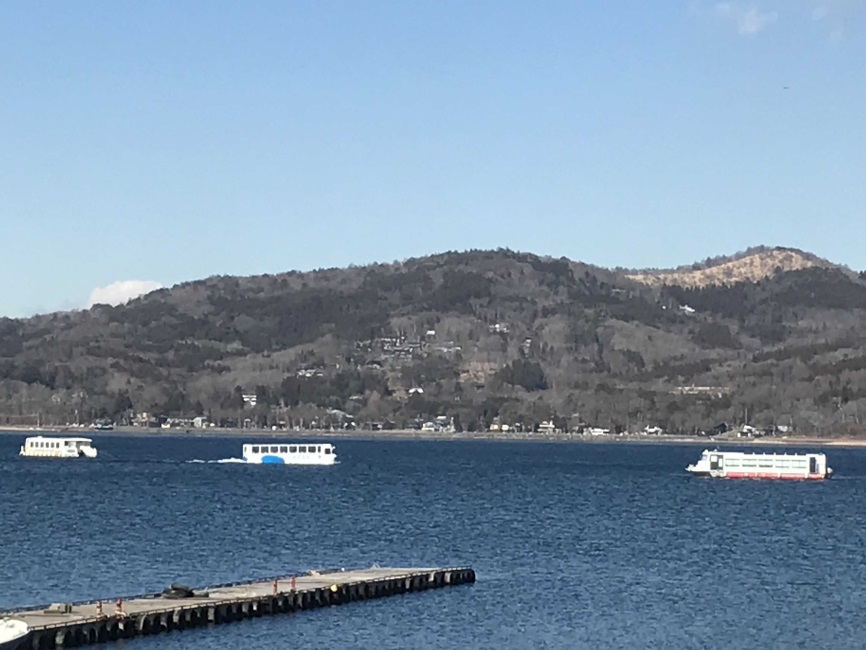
[686,449,833,480]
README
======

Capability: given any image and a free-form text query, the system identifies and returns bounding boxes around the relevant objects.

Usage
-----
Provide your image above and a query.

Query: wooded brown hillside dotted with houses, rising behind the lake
[0,249,866,435]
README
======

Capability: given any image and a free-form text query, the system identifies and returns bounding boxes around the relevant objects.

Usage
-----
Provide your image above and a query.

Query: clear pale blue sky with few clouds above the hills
[0,0,866,317]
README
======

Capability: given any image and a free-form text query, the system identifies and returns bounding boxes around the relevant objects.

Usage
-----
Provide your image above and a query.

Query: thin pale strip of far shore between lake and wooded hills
[0,426,866,447]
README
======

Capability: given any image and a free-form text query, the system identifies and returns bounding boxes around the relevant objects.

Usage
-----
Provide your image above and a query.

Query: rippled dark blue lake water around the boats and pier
[0,434,866,650]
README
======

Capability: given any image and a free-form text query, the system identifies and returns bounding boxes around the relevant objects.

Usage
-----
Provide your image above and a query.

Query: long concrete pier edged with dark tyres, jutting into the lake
[0,567,475,650]
